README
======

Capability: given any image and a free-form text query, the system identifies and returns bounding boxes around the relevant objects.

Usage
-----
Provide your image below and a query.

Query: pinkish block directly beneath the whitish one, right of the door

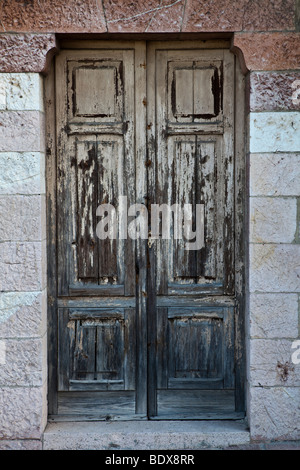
[250,153,300,196]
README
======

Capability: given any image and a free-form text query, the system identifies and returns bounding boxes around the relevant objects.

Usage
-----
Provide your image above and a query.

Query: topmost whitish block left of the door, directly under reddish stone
[0,73,44,111]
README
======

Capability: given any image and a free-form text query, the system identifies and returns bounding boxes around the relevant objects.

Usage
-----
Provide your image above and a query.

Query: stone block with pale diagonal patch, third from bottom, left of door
[0,290,47,338]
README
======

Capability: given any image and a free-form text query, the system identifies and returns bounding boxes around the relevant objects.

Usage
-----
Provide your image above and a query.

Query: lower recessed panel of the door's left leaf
[59,308,135,390]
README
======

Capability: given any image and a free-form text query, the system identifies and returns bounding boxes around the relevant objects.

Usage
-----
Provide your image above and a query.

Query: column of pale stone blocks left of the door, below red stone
[0,73,47,448]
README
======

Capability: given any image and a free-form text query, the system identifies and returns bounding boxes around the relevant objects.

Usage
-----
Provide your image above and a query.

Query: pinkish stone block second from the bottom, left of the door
[0,335,47,387]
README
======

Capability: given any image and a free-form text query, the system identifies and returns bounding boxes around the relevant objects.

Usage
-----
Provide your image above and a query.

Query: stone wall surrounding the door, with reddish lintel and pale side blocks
[0,0,300,448]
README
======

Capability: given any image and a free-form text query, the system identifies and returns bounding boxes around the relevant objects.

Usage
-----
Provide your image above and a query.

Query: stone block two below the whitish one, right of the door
[250,197,297,243]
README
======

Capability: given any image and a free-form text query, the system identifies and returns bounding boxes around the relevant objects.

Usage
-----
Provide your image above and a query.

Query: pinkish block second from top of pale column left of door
[0,111,45,152]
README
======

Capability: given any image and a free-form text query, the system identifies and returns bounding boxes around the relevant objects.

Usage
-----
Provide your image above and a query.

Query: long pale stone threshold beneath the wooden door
[43,420,250,451]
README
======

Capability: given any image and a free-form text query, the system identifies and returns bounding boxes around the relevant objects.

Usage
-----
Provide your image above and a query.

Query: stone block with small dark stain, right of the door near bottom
[249,339,300,387]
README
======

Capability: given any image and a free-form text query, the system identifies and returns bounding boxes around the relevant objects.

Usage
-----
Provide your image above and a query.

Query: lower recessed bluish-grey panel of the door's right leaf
[168,308,224,388]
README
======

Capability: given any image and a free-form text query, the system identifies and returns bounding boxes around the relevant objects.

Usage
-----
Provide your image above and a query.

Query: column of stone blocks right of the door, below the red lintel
[249,70,300,439]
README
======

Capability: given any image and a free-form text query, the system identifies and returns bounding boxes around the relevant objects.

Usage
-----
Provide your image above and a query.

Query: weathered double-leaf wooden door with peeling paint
[48,41,245,419]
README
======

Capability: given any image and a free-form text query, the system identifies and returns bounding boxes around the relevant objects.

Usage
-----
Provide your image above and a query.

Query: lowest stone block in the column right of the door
[248,387,300,440]
